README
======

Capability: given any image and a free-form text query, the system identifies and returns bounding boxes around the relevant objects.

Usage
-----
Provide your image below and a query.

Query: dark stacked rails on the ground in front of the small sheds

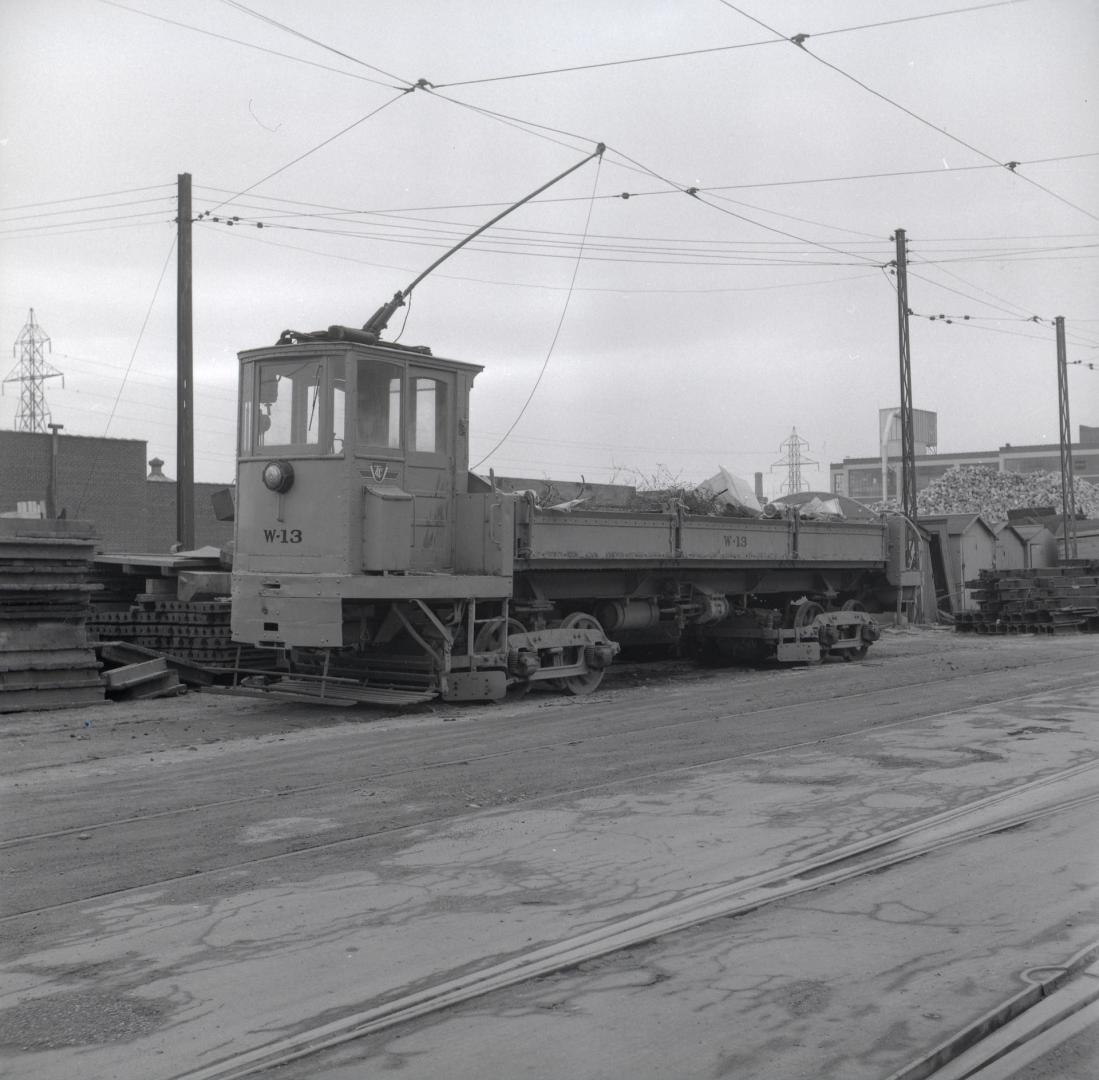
[955,560,1099,634]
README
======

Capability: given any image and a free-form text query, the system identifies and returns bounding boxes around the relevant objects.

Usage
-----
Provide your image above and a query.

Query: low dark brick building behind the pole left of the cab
[0,431,233,554]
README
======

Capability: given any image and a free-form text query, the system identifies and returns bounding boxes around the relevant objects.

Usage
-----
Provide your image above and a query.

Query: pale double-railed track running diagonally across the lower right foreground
[169,762,1099,1080]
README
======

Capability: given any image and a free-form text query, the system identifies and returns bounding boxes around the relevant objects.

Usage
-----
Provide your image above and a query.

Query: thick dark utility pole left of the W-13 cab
[176,172,195,550]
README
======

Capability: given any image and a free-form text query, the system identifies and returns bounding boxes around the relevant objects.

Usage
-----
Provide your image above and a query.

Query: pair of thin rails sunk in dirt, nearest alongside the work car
[0,661,1094,925]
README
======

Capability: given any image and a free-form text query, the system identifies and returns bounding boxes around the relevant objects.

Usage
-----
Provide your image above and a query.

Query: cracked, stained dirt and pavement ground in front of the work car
[0,630,1099,1080]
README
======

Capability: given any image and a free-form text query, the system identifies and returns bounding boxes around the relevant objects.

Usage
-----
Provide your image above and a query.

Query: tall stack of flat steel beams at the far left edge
[0,517,103,713]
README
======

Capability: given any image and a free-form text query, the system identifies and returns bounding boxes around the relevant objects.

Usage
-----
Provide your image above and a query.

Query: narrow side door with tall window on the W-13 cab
[404,365,455,570]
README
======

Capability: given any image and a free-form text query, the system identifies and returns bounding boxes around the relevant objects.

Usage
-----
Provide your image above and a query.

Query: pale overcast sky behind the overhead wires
[0,0,1099,493]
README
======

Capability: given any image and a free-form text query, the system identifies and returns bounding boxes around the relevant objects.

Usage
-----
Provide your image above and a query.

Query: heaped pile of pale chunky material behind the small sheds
[915,465,1099,525]
